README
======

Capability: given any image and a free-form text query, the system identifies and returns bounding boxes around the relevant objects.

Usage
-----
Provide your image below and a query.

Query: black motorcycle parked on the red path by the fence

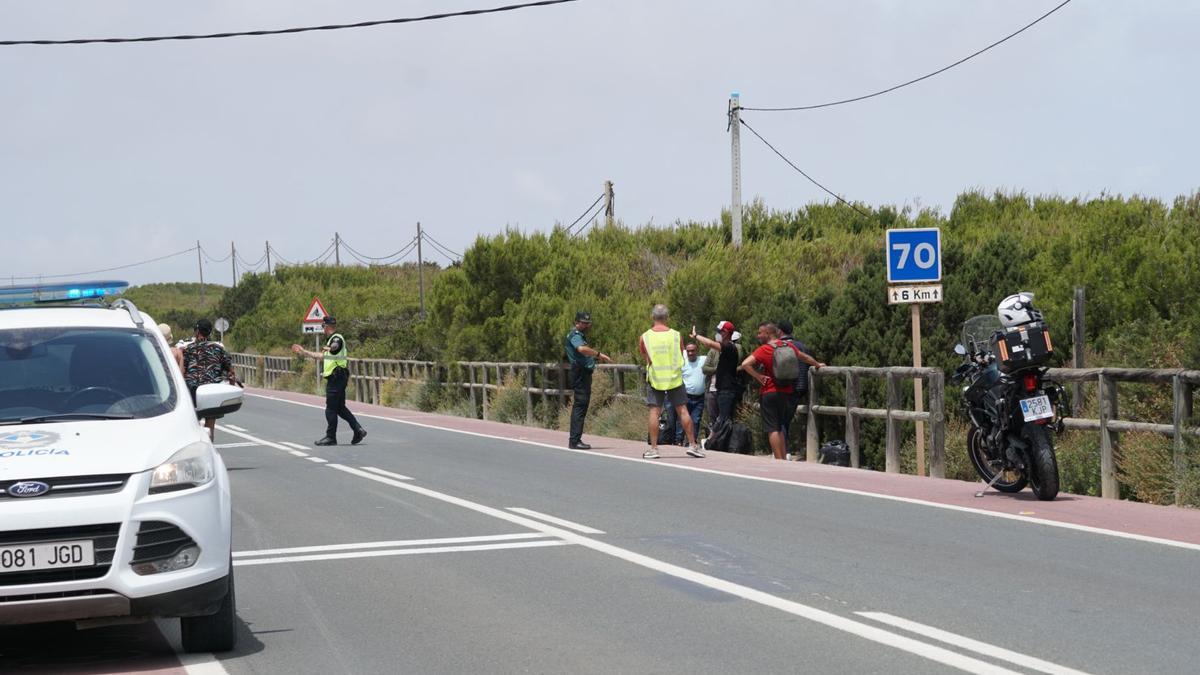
[952,307,1064,501]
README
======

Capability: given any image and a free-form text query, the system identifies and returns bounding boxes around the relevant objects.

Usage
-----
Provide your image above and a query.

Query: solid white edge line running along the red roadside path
[246,394,1200,551]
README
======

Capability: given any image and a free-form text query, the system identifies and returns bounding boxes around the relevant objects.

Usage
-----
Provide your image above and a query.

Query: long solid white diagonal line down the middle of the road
[328,464,1016,675]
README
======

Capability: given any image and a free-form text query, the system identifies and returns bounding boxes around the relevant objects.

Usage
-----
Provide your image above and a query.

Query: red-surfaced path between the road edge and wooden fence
[246,388,1200,551]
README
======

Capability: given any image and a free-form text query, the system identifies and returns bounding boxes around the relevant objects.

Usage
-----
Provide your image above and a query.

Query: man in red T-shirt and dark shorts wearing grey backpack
[742,321,824,459]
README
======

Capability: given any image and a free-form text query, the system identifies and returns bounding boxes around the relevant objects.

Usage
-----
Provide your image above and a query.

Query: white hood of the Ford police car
[0,416,208,482]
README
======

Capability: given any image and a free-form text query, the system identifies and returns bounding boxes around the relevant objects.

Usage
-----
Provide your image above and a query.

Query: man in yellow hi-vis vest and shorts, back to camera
[637,305,704,459]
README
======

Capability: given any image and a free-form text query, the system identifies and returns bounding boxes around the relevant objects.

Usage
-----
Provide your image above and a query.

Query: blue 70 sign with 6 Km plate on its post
[884,227,943,476]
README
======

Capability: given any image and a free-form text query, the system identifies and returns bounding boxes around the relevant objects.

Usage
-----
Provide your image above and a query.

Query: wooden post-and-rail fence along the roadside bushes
[233,354,1200,501]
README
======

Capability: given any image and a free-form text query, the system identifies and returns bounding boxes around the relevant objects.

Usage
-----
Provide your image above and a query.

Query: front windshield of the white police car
[0,328,176,424]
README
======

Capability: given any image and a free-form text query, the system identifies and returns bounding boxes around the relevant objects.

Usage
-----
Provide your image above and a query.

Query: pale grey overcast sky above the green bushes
[0,0,1200,283]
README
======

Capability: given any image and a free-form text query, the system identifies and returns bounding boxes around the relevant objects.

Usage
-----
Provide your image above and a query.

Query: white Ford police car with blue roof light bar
[0,282,242,651]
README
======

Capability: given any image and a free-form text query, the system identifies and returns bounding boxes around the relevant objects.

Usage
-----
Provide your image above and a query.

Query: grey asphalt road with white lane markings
[0,398,1200,674]
